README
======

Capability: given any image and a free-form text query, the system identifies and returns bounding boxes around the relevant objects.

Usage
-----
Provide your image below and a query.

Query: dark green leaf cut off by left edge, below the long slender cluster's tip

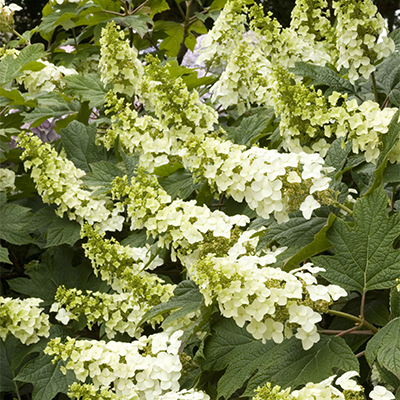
[0,204,33,245]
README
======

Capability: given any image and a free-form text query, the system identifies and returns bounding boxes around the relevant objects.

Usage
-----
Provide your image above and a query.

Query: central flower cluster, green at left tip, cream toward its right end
[113,170,248,249]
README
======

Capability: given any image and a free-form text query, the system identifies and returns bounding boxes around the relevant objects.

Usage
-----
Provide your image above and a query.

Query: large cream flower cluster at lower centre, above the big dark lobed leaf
[188,231,346,350]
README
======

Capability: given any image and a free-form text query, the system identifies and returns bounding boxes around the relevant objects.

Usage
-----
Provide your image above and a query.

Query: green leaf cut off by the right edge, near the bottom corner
[365,317,400,379]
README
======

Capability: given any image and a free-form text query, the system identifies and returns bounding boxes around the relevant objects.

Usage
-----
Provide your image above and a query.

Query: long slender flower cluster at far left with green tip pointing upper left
[18,133,124,230]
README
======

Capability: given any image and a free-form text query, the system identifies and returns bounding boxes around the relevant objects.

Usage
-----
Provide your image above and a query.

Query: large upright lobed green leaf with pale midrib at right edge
[313,188,400,293]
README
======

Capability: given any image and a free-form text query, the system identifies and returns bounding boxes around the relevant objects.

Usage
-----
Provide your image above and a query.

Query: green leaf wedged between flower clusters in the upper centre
[228,107,275,147]
